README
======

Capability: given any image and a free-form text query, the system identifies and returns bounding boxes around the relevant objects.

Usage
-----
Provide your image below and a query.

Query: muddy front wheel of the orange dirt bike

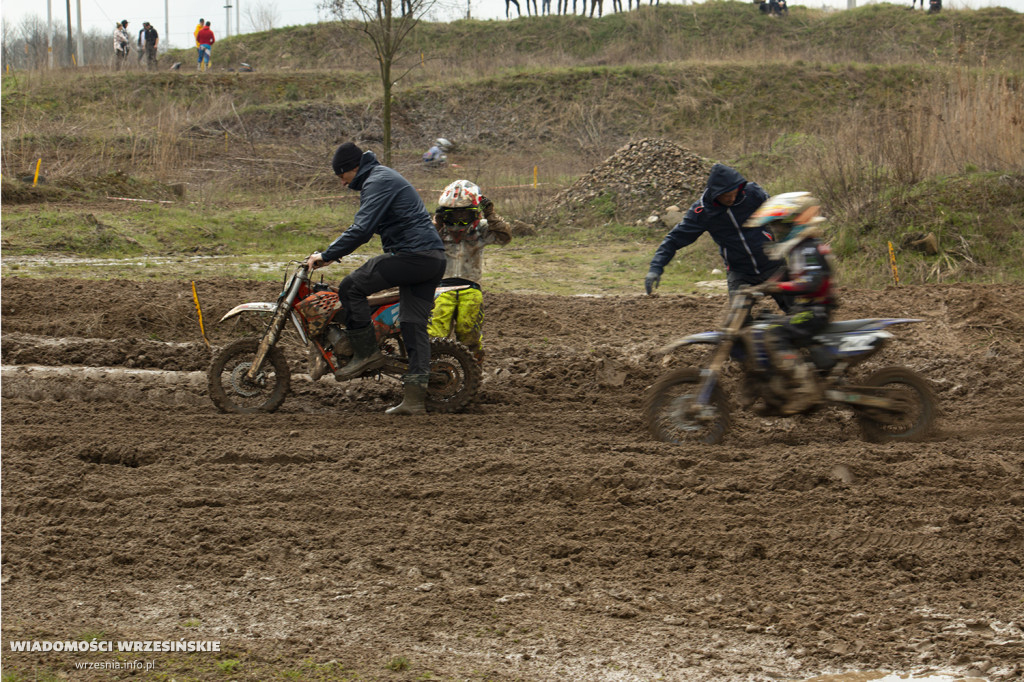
[207,338,292,415]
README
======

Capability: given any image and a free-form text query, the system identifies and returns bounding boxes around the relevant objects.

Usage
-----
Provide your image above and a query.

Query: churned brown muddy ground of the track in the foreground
[2,279,1024,681]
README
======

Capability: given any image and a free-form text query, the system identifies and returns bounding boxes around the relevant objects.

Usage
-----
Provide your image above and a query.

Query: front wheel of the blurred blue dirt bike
[643,368,730,445]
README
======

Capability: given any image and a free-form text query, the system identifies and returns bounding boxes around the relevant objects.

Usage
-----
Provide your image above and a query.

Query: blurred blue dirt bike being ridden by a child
[643,291,938,444]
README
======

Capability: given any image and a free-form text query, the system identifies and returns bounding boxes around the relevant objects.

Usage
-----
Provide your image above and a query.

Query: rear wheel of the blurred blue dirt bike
[857,367,939,442]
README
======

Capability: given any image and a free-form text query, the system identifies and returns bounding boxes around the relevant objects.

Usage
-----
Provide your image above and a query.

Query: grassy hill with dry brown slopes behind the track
[2,2,1024,286]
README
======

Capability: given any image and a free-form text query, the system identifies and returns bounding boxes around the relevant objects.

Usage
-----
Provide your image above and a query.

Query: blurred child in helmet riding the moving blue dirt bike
[744,191,837,415]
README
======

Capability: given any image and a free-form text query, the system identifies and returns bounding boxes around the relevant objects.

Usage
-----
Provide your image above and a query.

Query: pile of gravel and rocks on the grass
[544,138,714,227]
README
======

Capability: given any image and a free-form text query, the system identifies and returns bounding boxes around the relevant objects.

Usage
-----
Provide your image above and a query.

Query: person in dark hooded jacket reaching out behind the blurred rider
[644,164,791,311]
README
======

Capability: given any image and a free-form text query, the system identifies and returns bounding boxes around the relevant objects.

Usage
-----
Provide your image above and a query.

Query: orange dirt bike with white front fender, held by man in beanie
[208,261,482,414]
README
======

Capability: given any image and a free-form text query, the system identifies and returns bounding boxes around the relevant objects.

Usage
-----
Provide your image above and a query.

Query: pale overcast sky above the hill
[0,0,1024,47]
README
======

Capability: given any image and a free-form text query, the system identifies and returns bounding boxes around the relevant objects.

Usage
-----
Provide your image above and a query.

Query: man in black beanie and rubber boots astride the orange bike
[306,142,446,415]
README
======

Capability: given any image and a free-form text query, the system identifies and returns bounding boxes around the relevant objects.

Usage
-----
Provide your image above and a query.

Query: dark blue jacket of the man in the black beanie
[321,152,444,263]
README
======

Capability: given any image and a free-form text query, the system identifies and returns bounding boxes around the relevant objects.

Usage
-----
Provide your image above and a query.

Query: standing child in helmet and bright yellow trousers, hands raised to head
[428,180,512,363]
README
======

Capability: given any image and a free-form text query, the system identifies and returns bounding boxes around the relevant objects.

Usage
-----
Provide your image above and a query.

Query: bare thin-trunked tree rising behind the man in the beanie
[322,0,437,164]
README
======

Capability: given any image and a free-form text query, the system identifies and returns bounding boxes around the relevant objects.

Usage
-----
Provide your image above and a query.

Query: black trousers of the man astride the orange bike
[338,249,446,375]
